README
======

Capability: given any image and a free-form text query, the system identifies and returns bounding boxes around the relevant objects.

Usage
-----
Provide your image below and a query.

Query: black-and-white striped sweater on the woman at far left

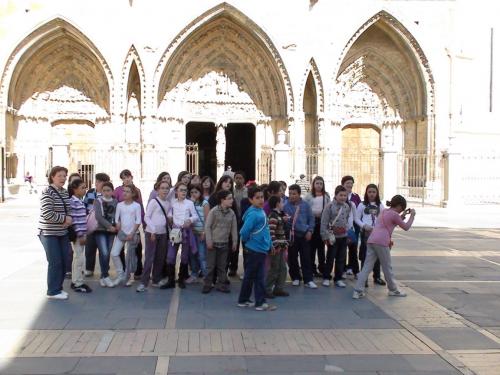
[38,186,71,236]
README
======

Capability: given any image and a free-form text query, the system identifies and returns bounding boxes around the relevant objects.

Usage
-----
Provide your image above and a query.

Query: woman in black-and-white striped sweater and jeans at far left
[38,166,73,300]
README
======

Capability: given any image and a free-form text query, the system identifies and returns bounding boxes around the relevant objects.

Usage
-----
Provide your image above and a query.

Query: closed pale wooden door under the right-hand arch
[342,124,381,194]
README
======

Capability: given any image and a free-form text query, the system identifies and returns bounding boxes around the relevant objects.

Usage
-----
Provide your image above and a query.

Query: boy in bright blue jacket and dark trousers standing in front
[238,187,276,311]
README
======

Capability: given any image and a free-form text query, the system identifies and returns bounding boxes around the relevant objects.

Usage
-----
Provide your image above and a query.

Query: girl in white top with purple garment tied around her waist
[162,182,198,289]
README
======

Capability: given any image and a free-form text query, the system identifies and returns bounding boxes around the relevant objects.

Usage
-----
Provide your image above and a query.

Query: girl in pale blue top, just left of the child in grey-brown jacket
[186,185,210,284]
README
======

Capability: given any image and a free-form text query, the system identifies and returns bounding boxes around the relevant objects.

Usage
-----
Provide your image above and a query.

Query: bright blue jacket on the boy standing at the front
[240,206,272,253]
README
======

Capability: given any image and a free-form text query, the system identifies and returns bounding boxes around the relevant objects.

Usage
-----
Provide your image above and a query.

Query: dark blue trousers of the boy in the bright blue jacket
[238,249,267,307]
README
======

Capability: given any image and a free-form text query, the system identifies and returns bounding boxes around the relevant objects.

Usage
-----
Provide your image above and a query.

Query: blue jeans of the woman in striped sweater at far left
[38,234,70,296]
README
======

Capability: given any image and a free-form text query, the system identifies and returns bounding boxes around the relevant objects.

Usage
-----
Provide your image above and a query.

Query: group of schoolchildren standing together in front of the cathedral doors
[41,167,415,311]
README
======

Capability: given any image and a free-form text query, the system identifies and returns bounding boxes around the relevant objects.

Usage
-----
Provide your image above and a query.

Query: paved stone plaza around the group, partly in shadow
[0,197,500,375]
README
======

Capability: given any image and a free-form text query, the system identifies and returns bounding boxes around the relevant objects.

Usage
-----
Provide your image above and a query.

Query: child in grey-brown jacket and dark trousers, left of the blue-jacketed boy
[202,190,238,293]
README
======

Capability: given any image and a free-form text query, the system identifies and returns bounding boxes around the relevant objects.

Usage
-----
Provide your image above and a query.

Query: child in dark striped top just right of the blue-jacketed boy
[266,196,290,298]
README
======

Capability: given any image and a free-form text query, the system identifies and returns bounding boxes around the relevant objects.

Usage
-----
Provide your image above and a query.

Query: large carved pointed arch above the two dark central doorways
[153,3,294,120]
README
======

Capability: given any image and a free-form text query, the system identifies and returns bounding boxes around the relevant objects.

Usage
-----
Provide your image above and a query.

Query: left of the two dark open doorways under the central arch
[186,122,217,179]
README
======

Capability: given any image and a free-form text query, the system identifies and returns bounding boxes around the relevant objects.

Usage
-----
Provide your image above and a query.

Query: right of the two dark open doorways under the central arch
[224,123,255,180]
